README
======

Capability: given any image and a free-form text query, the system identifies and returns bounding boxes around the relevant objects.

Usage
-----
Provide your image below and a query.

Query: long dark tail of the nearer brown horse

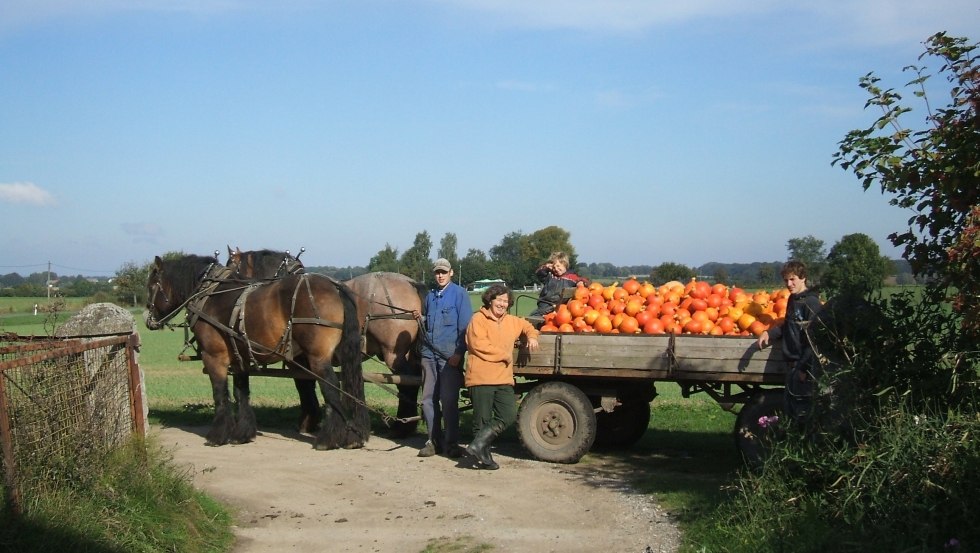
[335,281,371,436]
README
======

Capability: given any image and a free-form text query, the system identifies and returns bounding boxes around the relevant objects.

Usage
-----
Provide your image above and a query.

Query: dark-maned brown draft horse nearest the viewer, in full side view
[146,255,370,450]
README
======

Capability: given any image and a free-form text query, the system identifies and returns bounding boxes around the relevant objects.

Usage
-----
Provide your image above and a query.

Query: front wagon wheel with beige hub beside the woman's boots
[517,382,596,463]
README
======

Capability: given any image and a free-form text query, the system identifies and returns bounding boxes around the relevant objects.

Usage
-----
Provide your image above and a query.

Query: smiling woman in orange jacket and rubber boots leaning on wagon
[466,284,541,470]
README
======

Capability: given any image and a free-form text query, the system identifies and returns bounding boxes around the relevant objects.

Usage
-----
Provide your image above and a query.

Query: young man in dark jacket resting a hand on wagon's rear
[757,260,822,422]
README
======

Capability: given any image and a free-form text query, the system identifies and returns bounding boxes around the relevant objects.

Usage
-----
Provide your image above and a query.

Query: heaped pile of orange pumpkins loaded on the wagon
[541,278,789,336]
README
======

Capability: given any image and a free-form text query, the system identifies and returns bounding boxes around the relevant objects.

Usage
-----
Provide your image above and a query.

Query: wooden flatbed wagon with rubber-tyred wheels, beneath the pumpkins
[514,333,787,463]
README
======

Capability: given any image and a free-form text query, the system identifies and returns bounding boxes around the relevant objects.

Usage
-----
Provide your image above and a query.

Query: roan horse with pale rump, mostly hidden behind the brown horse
[227,247,427,438]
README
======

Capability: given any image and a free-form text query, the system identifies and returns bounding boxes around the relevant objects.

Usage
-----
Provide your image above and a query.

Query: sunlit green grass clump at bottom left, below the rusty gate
[0,440,233,553]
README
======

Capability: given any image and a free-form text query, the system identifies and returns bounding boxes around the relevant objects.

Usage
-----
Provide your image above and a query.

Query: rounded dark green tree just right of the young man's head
[821,233,892,297]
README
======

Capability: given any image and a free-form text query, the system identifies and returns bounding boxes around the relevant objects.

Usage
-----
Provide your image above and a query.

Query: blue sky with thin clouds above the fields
[0,0,980,276]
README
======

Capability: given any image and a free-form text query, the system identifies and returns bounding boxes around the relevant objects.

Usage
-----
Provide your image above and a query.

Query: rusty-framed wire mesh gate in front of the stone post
[0,333,146,513]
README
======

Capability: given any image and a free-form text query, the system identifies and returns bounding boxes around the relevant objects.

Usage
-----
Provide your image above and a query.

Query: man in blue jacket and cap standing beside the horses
[418,258,473,458]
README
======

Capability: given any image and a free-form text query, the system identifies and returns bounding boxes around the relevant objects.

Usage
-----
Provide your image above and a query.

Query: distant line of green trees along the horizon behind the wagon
[0,226,915,306]
